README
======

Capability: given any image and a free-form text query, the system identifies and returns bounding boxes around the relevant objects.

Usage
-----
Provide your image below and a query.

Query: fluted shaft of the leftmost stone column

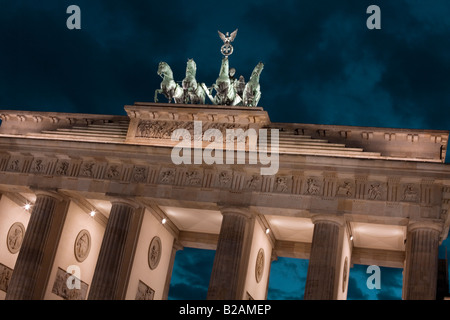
[6,193,61,300]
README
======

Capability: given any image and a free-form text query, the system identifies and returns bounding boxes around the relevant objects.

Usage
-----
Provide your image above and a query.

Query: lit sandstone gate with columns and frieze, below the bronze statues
[0,103,450,300]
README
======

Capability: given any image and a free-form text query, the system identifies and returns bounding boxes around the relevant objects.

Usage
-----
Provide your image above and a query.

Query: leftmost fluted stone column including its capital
[6,191,65,300]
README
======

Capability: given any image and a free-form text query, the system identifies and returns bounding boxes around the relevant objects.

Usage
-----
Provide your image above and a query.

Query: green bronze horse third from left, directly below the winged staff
[202,57,241,106]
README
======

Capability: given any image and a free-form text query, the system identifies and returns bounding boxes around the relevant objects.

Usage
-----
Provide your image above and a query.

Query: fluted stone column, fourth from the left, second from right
[304,215,344,300]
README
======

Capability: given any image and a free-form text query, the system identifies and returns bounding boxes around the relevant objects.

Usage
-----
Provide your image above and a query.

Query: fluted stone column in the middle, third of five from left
[207,207,252,300]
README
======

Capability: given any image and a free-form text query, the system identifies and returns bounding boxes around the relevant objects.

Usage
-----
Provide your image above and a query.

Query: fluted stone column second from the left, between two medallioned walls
[88,200,137,300]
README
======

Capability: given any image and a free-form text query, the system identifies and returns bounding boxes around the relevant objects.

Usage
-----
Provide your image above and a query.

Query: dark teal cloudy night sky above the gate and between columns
[0,0,450,299]
